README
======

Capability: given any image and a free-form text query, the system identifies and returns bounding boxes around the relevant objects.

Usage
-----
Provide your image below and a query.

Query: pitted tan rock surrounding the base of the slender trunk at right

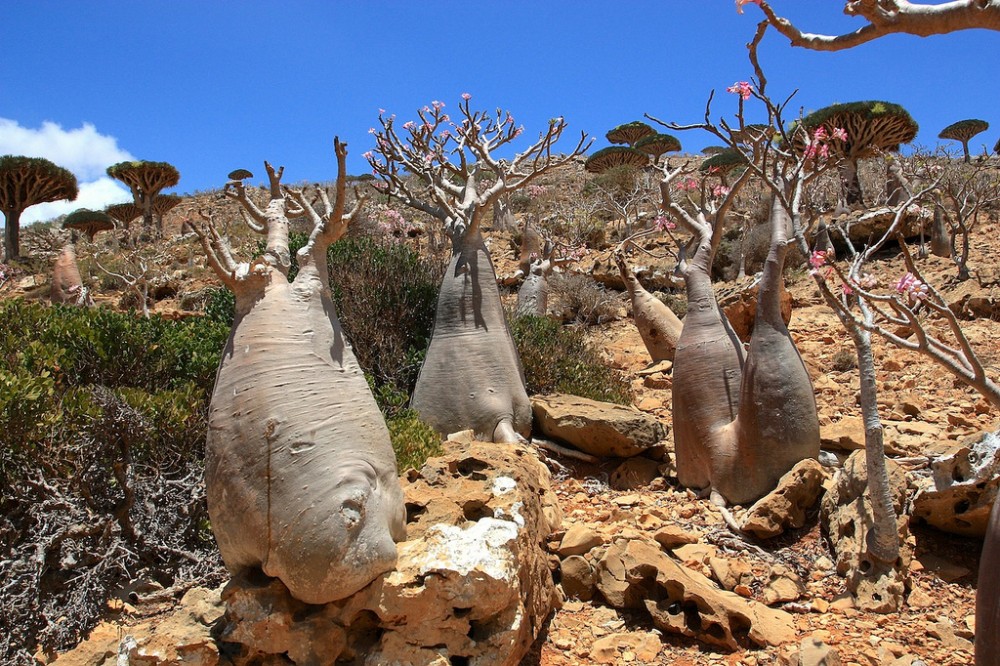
[821,451,913,613]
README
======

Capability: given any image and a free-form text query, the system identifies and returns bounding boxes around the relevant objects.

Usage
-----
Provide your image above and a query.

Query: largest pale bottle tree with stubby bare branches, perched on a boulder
[188,139,405,604]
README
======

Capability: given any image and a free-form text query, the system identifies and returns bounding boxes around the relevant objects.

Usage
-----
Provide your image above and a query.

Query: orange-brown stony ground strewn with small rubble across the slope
[15,197,1000,666]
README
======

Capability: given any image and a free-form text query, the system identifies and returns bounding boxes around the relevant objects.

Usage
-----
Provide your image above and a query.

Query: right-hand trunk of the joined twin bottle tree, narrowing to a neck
[712,200,820,504]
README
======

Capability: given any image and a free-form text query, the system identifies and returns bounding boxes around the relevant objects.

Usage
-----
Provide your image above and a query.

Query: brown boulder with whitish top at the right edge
[913,432,1000,538]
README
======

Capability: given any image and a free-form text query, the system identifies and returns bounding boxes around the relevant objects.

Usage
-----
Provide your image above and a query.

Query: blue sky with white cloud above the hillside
[0,0,1000,222]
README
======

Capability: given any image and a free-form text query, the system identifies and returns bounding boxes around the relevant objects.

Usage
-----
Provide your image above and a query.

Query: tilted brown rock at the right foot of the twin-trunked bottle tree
[742,458,826,539]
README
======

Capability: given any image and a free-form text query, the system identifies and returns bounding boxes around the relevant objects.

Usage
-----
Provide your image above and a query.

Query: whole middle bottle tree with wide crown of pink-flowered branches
[366,94,587,442]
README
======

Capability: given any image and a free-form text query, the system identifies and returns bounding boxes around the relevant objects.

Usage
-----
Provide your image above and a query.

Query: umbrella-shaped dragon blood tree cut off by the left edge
[0,155,79,261]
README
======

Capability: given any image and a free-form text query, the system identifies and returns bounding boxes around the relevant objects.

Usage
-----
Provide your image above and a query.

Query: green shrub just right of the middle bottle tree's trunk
[511,316,634,405]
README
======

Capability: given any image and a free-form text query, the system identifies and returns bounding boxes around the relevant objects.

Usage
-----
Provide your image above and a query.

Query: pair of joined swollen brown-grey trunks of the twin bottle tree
[673,201,819,504]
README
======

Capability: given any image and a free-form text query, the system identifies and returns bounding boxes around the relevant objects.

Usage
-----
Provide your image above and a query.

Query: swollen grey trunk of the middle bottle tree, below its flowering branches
[410,225,531,441]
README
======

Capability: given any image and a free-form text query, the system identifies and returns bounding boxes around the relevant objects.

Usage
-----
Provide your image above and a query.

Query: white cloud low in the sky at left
[0,118,135,225]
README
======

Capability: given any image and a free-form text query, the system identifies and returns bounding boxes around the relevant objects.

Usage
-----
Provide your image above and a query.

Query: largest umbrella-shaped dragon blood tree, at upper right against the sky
[792,101,918,207]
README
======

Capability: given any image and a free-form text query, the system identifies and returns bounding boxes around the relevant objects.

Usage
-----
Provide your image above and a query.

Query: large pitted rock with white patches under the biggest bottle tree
[222,442,559,666]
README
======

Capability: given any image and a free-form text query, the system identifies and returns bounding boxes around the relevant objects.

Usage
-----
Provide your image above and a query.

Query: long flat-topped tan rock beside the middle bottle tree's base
[532,394,666,458]
